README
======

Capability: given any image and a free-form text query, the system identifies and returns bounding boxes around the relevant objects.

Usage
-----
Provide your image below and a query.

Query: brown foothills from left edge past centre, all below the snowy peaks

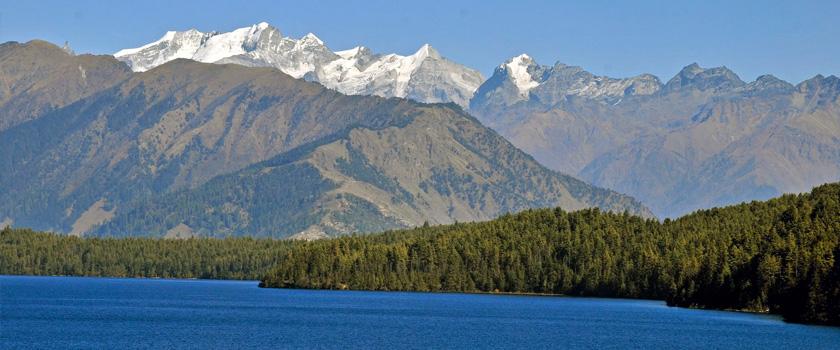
[0,40,652,239]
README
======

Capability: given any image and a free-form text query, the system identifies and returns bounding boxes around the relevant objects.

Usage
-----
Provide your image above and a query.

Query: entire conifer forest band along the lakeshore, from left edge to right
[0,184,840,325]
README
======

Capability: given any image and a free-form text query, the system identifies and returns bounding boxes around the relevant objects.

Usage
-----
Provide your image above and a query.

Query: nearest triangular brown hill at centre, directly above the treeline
[90,87,650,239]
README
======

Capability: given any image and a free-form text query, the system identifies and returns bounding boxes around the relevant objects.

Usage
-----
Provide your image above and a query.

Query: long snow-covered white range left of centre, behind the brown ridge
[114,22,484,106]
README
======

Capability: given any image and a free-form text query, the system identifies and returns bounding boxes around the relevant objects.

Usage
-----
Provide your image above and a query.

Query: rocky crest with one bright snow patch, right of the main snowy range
[471,54,663,108]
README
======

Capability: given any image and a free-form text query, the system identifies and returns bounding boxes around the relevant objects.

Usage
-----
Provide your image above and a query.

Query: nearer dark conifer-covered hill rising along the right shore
[263,184,840,324]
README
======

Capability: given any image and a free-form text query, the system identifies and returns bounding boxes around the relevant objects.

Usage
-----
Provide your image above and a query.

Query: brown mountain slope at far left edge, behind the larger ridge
[0,40,131,131]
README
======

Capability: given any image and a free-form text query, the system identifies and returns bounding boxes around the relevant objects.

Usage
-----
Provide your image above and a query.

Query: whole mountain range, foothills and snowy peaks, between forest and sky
[0,23,840,238]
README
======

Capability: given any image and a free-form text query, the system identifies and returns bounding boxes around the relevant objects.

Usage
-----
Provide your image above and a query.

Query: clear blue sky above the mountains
[0,0,840,83]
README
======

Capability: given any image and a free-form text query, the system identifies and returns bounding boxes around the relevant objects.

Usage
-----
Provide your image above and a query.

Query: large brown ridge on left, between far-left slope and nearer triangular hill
[0,55,430,233]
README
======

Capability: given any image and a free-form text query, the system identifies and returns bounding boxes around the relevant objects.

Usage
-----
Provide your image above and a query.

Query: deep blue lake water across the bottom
[0,276,840,349]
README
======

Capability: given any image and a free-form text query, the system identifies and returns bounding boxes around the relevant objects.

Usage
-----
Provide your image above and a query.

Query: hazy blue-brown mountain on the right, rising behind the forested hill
[471,56,840,217]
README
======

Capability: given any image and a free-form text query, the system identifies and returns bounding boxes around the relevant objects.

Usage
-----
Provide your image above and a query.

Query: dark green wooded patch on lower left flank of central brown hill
[94,163,335,238]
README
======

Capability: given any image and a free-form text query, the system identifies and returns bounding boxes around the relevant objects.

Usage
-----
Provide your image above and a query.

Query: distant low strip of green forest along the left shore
[0,228,294,280]
